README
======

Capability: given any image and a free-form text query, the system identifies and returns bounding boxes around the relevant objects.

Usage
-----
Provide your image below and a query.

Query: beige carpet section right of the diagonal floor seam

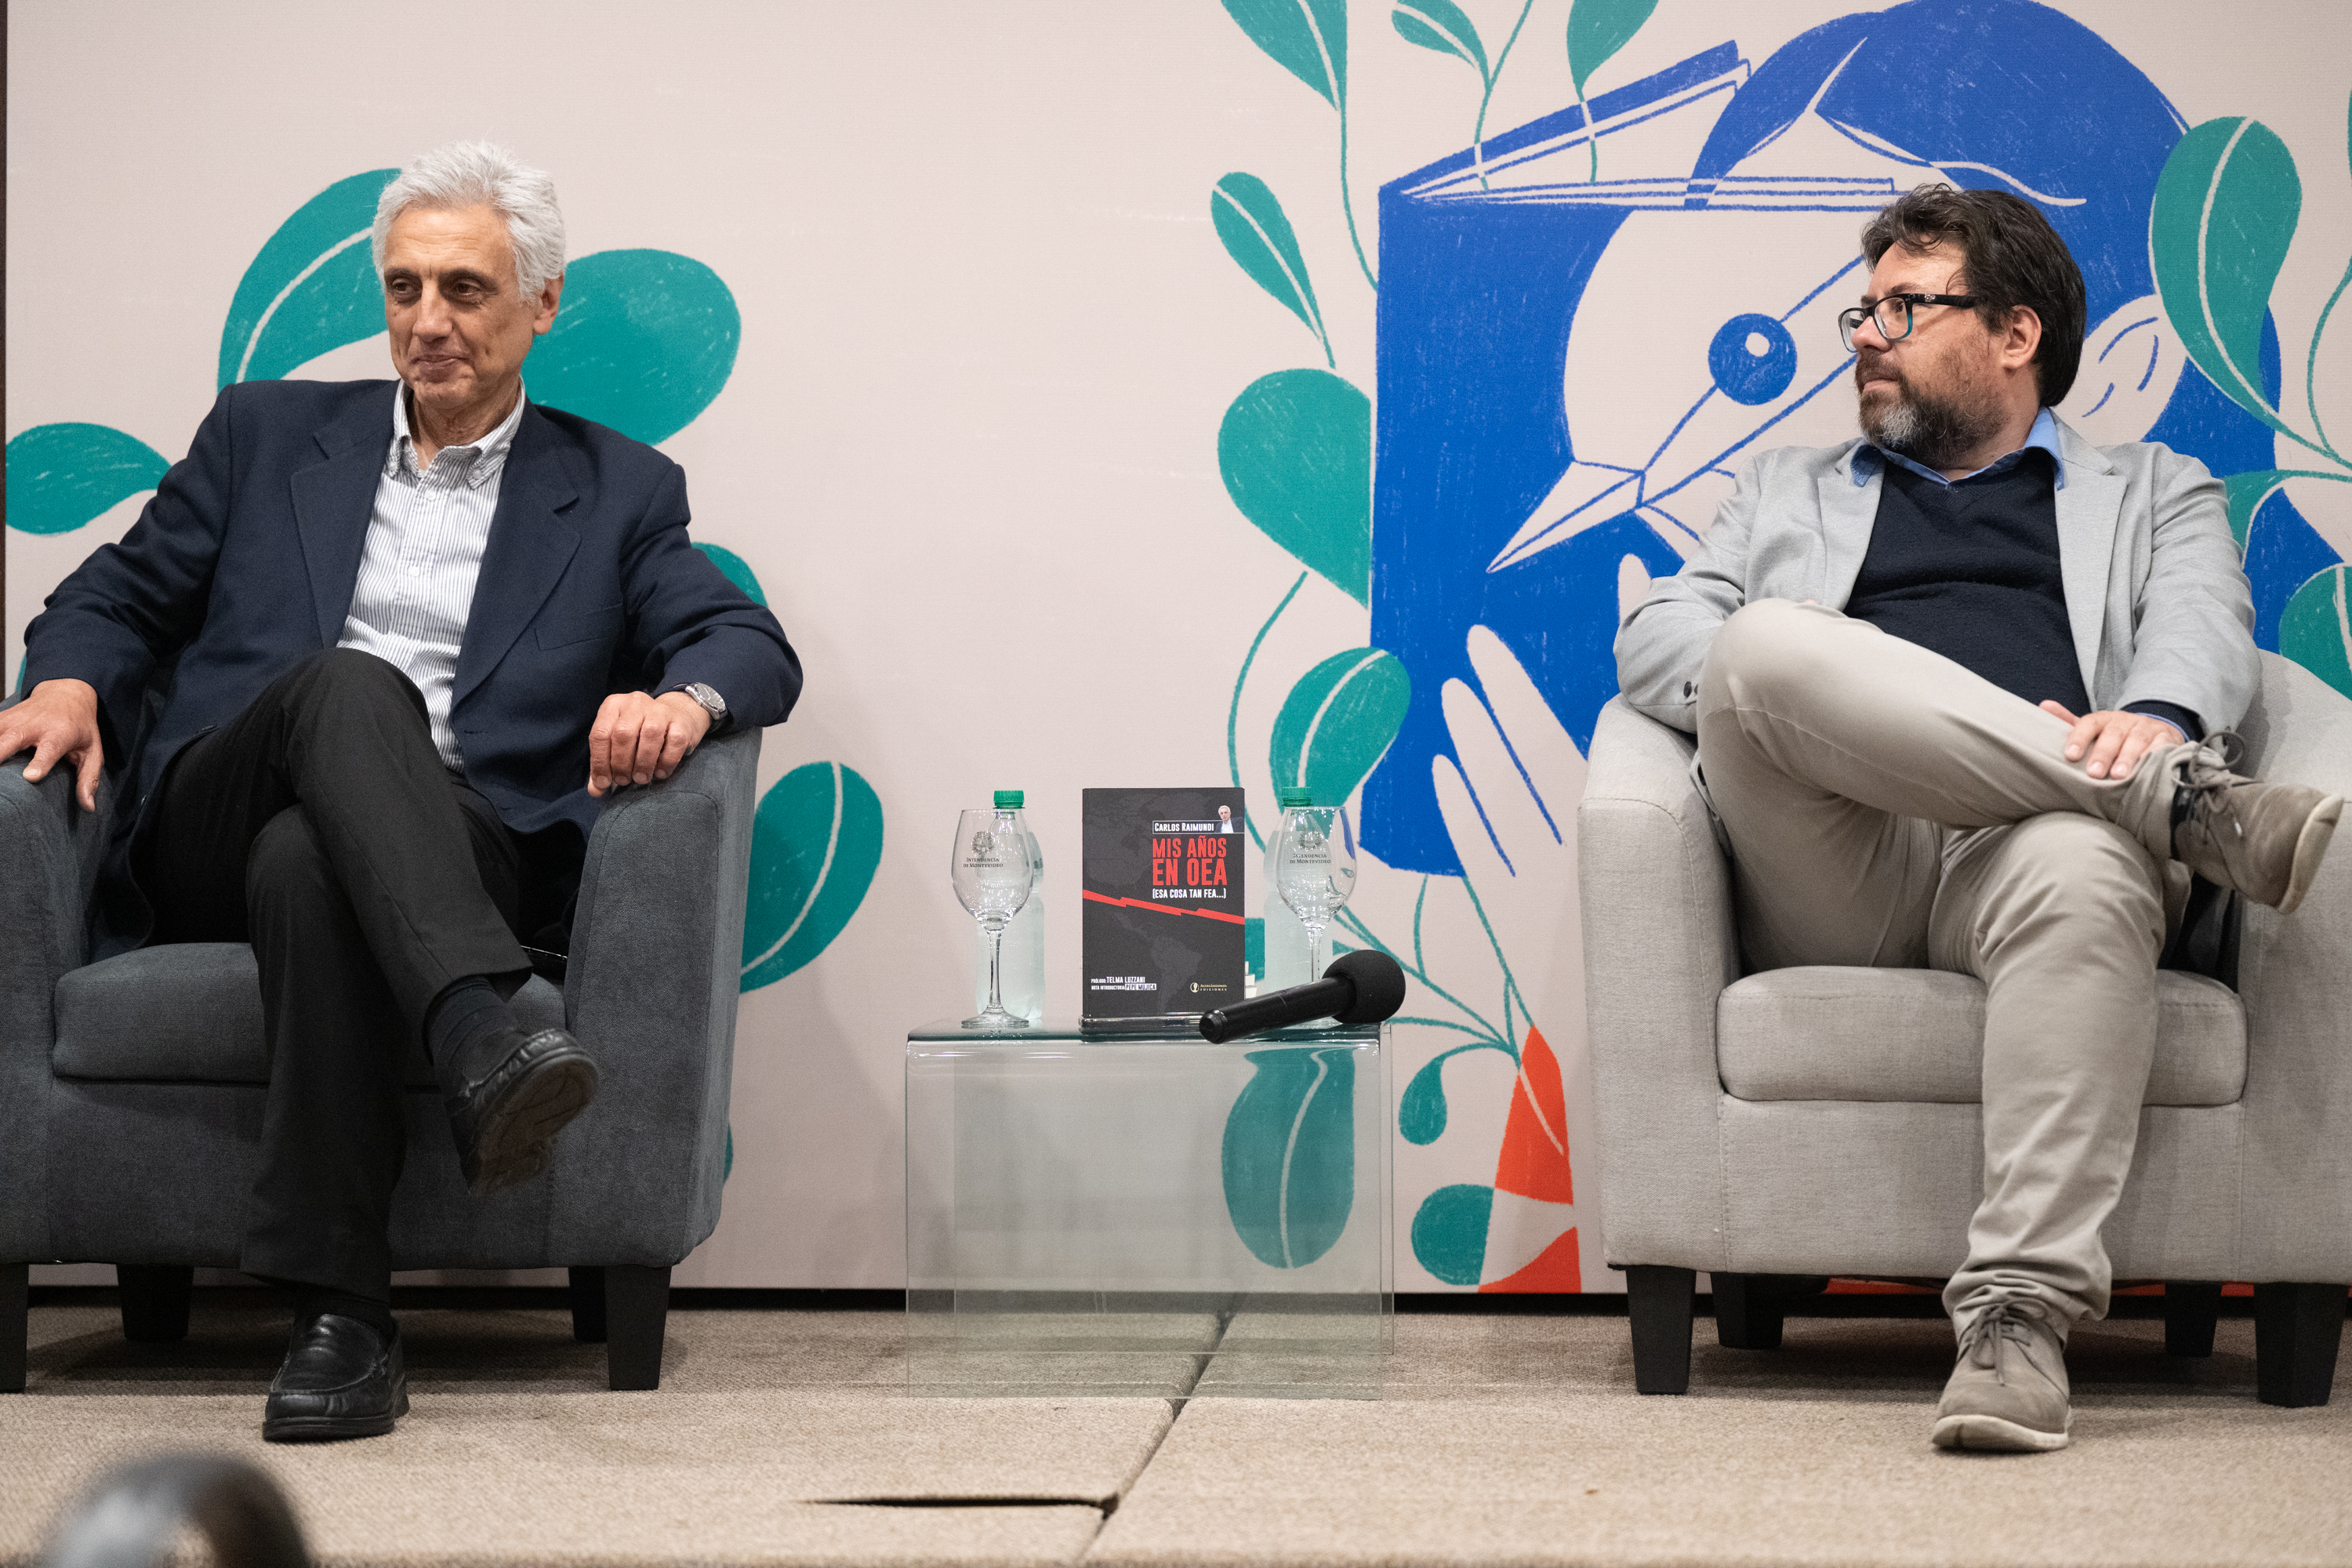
[1087,1316,2352,1568]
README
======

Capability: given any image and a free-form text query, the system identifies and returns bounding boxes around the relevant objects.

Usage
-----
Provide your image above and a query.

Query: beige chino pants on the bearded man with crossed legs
[1698,600,2176,1333]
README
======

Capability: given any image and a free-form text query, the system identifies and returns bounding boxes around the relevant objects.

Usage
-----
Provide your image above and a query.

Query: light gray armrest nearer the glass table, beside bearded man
[1576,699,1738,1269]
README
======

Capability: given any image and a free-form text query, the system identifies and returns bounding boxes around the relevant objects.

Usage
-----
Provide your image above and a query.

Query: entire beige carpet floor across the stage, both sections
[0,1307,2352,1568]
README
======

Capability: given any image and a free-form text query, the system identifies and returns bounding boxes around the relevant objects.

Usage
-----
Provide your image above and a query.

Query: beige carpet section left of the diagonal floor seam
[0,1305,1171,1568]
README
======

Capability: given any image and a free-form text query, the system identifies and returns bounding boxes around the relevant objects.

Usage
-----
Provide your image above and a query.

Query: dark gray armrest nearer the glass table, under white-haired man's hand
[548,729,760,1267]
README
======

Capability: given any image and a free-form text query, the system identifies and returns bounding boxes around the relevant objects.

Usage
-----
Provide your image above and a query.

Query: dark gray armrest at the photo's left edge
[0,755,113,1260]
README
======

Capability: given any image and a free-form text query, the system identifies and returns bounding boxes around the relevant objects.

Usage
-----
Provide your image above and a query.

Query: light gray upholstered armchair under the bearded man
[1576,654,2352,1406]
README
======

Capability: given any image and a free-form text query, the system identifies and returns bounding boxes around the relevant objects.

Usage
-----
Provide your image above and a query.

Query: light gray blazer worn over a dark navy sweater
[1616,421,2263,734]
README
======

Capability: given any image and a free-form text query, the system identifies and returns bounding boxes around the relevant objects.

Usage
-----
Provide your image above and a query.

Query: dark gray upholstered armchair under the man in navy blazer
[0,731,760,1392]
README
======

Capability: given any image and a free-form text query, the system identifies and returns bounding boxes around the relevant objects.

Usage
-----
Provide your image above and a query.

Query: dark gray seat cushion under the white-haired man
[49,942,564,1088]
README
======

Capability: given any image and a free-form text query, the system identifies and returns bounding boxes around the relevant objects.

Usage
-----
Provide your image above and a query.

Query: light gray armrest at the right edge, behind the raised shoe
[2237,654,2352,1283]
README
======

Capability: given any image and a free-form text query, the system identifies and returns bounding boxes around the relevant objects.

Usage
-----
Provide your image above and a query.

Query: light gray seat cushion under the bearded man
[1715,966,2246,1105]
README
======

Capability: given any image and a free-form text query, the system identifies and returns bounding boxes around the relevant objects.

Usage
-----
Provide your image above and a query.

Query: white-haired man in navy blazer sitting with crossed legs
[0,143,800,1441]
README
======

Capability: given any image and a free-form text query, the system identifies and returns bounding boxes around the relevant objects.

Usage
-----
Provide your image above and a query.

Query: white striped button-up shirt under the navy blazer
[336,388,524,769]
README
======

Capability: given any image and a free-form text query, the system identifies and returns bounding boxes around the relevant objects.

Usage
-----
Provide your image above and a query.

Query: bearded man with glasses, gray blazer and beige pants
[1616,183,2343,1453]
